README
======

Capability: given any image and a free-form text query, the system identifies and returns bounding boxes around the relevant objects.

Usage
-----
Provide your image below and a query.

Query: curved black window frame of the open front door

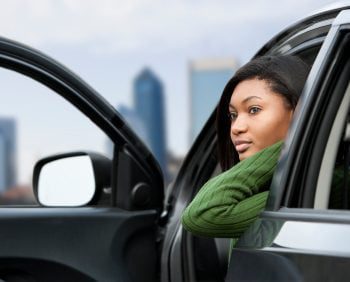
[0,37,164,209]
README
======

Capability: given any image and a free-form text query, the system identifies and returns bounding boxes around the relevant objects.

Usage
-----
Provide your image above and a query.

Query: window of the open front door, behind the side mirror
[0,68,112,205]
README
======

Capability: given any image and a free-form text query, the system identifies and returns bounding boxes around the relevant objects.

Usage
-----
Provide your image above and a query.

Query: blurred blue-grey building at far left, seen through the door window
[0,118,16,192]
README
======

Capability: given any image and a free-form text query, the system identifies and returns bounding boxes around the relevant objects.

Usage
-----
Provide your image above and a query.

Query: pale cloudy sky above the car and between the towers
[0,0,342,183]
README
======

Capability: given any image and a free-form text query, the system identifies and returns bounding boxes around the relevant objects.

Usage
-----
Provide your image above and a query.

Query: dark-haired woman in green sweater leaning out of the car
[182,56,309,242]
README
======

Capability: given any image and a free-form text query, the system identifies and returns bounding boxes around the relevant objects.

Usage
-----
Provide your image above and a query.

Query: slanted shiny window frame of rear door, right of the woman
[266,13,348,211]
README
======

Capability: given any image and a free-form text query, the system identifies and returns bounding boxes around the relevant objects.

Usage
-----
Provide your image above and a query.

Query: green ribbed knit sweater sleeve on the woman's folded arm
[182,141,283,238]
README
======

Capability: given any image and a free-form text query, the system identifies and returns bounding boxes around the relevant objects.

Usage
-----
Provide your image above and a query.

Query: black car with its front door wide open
[0,2,350,281]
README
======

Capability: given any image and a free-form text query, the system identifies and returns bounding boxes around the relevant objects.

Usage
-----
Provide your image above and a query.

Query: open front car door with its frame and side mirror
[0,38,163,281]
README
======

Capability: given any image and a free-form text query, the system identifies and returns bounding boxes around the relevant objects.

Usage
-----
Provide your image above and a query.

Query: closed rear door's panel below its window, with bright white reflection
[227,215,350,281]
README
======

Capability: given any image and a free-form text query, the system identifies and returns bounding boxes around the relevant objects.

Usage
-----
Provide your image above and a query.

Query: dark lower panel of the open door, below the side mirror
[0,207,157,281]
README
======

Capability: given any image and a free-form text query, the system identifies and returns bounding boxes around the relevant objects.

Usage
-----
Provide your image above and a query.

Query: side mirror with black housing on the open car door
[33,152,112,207]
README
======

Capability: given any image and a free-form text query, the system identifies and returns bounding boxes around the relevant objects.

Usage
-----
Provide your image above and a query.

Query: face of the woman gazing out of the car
[229,79,293,160]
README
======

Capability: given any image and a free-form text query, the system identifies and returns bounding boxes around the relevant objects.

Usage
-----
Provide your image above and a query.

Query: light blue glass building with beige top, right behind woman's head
[189,59,238,144]
